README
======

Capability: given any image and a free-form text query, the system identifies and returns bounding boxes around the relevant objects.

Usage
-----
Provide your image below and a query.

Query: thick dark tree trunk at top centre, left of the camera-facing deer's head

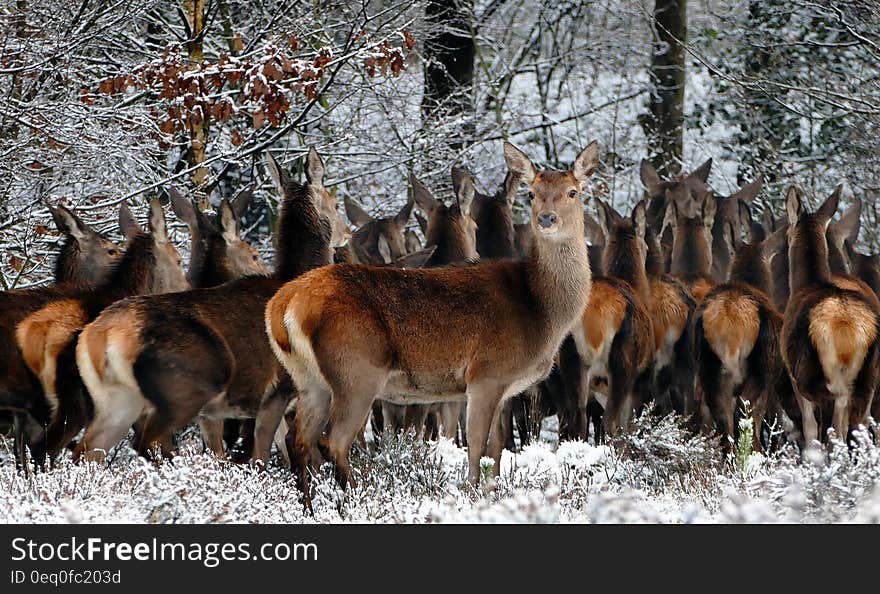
[422,0,475,146]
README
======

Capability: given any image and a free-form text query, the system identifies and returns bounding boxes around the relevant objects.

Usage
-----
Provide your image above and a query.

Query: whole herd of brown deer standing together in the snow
[0,142,880,506]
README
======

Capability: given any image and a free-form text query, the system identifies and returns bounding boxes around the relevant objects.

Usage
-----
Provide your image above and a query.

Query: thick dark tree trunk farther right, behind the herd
[643,0,687,177]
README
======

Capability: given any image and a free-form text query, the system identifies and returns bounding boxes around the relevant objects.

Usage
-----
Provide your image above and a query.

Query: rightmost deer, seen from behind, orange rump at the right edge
[781,187,880,445]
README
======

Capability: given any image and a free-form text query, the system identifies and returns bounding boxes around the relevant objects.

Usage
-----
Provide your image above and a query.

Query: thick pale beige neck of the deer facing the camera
[526,232,592,340]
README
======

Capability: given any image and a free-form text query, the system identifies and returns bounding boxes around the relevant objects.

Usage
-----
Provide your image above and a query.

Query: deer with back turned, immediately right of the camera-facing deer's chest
[572,199,654,435]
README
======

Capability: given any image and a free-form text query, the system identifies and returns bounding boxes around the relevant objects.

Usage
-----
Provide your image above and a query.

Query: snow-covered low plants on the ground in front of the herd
[0,415,880,523]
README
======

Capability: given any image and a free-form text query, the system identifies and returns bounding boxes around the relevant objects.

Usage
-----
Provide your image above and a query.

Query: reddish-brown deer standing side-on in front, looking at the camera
[266,142,599,505]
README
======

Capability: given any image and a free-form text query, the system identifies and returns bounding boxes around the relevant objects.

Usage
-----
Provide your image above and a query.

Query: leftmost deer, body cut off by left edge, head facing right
[0,201,122,465]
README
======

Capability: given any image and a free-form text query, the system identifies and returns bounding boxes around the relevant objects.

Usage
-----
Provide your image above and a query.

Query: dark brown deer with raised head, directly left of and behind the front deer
[74,149,347,463]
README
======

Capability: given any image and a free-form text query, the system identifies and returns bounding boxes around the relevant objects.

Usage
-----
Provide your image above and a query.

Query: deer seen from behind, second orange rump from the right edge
[693,202,786,451]
